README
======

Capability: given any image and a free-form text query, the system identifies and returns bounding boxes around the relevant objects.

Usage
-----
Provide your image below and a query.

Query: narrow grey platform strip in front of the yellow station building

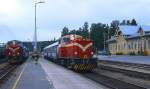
[98,55,150,64]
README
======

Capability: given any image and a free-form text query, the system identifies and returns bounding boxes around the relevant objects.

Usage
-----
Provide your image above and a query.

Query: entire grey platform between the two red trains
[12,58,108,89]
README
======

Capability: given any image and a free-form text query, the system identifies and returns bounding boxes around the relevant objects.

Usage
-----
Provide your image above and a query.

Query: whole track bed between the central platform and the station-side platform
[83,61,150,89]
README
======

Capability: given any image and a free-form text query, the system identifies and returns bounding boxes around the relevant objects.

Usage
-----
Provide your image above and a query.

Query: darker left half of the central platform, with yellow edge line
[12,60,53,89]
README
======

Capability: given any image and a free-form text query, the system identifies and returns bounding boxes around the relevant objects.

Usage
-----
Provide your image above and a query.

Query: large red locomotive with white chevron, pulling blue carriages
[44,34,97,71]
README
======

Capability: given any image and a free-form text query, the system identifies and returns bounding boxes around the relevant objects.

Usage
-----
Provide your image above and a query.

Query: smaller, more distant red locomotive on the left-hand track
[5,40,29,64]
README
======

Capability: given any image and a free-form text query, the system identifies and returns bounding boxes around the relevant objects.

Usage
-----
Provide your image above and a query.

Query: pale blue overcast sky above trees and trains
[0,0,150,42]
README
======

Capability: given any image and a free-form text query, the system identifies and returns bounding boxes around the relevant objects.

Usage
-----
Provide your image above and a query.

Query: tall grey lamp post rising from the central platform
[34,2,45,52]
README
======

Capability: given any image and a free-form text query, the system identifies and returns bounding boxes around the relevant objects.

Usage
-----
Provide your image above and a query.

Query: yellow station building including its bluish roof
[107,26,150,55]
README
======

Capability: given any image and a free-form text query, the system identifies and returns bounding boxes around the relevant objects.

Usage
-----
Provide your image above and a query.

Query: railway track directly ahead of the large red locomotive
[82,72,146,89]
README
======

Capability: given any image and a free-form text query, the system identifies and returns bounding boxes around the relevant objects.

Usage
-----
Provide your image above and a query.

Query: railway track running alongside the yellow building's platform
[98,61,150,80]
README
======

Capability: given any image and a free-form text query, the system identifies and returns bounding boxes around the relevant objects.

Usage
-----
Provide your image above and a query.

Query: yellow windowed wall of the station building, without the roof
[108,36,150,55]
